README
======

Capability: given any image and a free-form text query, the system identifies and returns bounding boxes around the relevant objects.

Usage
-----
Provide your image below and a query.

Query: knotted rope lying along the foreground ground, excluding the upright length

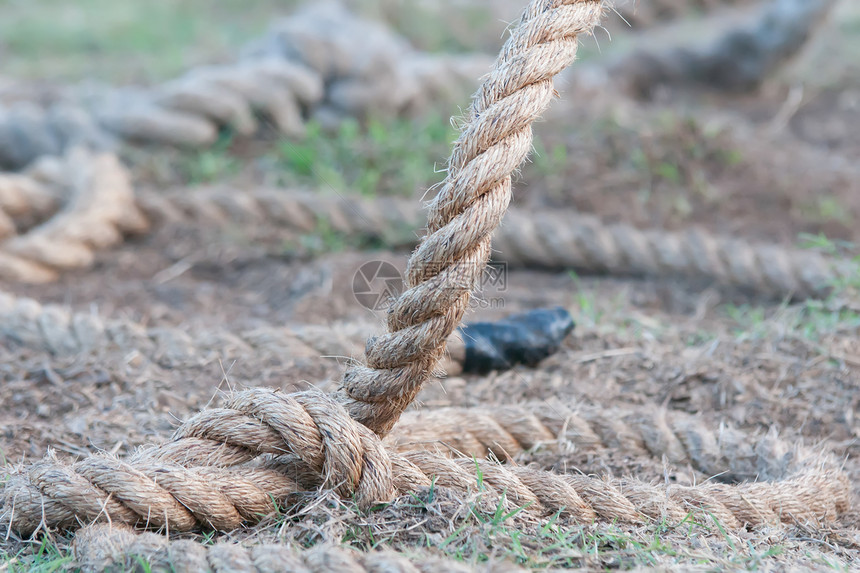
[3,389,851,535]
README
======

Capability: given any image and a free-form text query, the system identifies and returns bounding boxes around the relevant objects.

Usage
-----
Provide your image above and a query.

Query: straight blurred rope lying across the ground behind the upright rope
[139,189,848,299]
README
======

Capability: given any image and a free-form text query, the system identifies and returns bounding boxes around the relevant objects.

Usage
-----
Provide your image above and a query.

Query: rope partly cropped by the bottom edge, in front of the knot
[74,525,522,573]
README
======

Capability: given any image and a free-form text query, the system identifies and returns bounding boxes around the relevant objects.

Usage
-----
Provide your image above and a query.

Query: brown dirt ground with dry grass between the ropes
[0,1,860,571]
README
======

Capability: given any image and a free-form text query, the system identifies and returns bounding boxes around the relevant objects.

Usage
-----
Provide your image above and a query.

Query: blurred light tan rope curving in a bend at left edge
[0,149,148,283]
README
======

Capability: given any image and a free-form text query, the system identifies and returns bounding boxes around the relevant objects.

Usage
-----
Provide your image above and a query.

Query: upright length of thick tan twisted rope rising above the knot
[336,0,604,435]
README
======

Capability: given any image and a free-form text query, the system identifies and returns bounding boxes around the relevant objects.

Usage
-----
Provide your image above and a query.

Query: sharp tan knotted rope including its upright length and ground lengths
[3,0,851,564]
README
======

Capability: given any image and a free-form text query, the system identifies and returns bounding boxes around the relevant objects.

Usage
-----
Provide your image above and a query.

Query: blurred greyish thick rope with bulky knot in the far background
[0,3,489,169]
